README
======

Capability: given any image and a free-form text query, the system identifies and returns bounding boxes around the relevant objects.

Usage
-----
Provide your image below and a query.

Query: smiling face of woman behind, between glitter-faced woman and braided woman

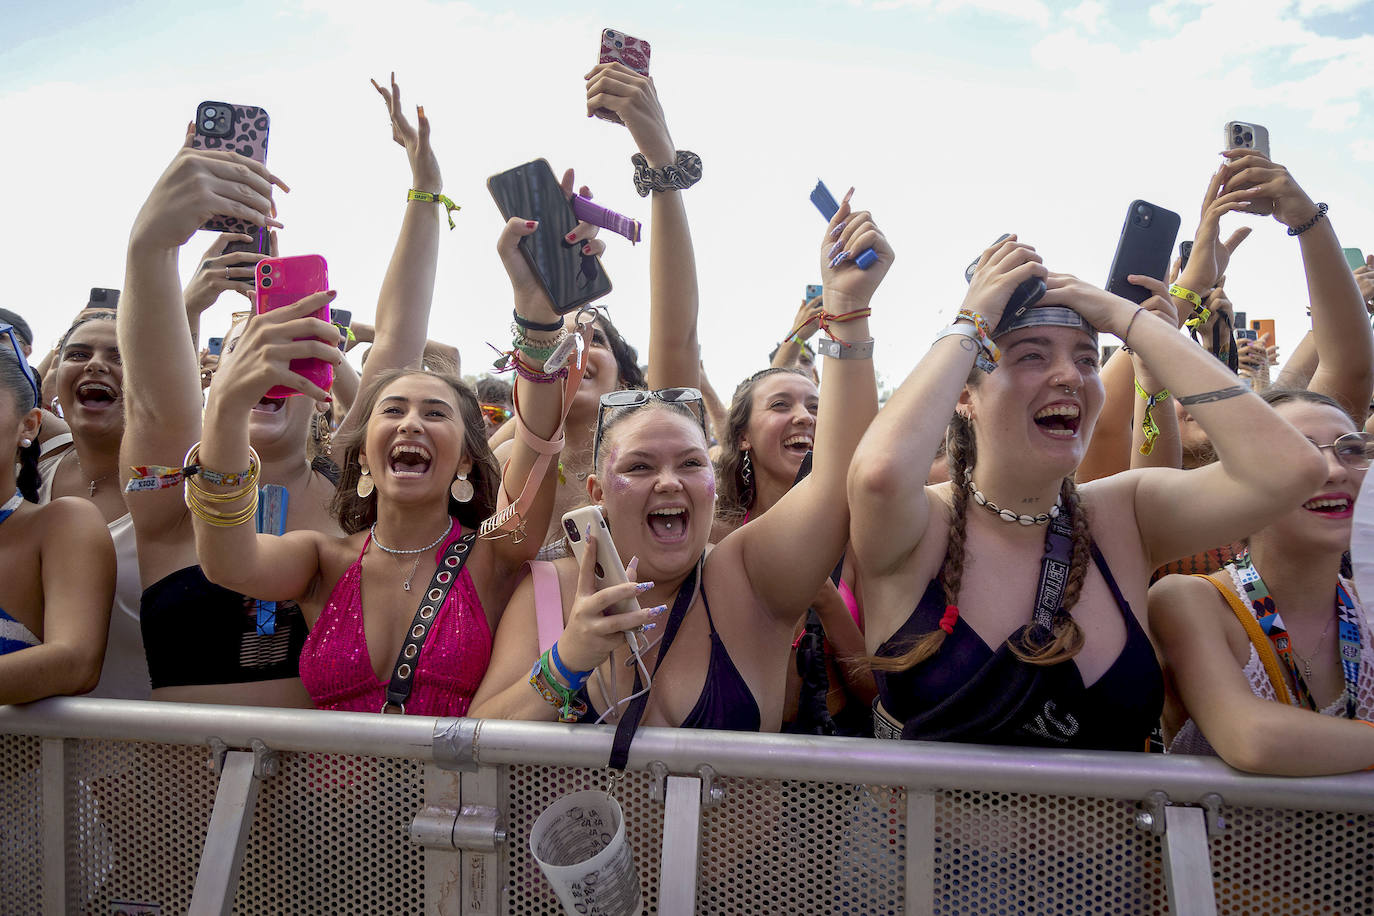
[739,372,820,482]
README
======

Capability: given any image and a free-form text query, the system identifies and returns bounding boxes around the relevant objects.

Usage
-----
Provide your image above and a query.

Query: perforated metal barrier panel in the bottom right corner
[1210,808,1374,916]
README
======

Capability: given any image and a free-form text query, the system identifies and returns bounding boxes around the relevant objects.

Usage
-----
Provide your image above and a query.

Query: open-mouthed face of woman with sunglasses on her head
[587,404,716,580]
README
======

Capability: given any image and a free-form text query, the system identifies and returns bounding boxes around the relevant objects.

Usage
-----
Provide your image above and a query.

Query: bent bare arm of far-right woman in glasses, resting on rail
[1150,575,1374,776]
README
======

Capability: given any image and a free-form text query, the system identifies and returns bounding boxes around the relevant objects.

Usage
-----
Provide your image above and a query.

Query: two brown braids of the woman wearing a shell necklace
[868,413,1091,672]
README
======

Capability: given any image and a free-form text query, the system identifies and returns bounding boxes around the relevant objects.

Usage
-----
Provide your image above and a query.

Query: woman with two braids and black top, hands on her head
[849,168,1325,750]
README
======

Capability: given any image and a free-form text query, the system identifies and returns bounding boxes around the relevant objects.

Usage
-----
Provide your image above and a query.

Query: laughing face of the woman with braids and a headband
[960,327,1103,477]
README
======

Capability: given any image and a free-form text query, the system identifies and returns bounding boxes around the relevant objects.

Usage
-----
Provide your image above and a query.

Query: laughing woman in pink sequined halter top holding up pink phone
[187,157,602,715]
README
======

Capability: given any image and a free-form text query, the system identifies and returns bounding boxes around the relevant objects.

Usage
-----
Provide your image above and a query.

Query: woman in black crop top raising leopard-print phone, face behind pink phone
[120,80,444,706]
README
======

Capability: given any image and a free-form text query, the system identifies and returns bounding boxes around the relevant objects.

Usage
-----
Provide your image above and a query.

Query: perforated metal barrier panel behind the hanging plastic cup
[502,766,664,916]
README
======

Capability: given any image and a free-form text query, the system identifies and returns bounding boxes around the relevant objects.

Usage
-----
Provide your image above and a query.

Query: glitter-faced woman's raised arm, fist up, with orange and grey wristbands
[736,191,893,623]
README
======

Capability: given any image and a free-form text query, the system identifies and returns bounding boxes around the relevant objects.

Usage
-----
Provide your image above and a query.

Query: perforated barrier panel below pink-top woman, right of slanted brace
[235,754,425,916]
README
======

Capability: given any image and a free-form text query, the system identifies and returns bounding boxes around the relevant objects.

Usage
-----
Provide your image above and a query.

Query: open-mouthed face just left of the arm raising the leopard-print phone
[58,320,124,435]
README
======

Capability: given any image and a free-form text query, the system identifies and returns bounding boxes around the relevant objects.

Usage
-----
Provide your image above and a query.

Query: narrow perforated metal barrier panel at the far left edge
[0,735,43,913]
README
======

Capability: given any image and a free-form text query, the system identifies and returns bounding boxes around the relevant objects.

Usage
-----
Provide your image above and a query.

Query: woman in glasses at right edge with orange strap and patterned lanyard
[1150,389,1374,776]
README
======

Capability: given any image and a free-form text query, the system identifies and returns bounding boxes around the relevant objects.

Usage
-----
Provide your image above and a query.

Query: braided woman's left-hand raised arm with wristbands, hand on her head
[846,235,1046,577]
